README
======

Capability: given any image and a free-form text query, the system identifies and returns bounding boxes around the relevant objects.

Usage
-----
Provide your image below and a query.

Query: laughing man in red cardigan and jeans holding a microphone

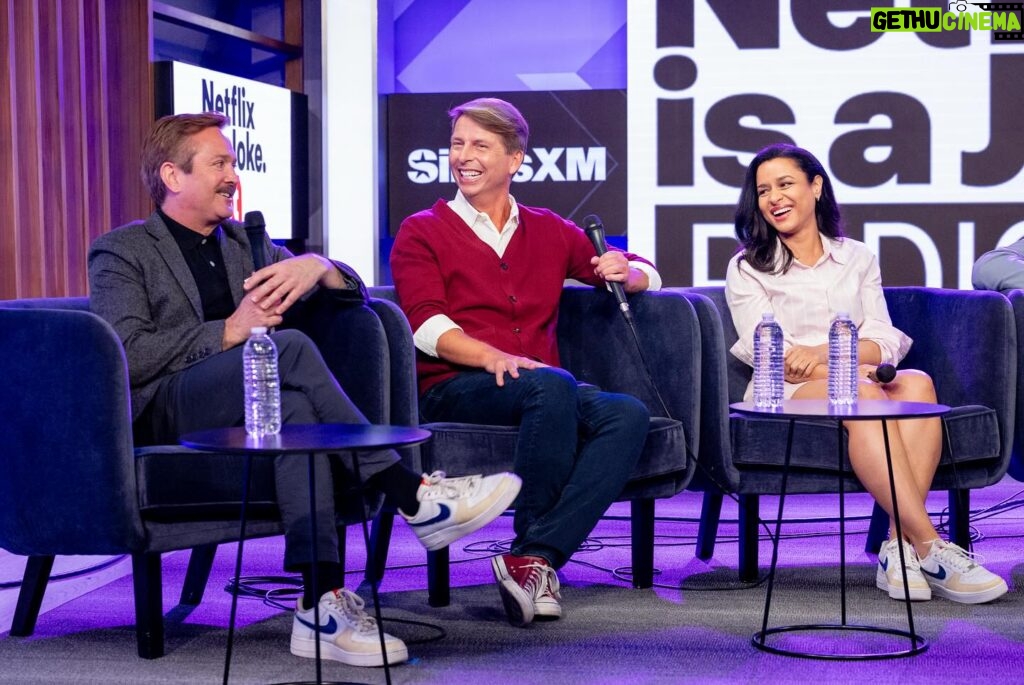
[391,98,660,626]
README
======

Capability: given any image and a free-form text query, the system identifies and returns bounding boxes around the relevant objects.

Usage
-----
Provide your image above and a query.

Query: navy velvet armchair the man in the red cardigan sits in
[371,287,701,606]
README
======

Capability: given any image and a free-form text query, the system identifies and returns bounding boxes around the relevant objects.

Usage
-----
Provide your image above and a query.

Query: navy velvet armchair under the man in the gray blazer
[0,298,401,658]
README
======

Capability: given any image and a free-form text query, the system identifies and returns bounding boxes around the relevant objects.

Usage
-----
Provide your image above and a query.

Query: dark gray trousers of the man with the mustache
[136,330,399,570]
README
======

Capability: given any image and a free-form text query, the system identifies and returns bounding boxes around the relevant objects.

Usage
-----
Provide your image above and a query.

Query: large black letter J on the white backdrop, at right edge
[961,53,1024,186]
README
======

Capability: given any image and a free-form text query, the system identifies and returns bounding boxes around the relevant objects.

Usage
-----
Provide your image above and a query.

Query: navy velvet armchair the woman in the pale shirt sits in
[681,288,1017,581]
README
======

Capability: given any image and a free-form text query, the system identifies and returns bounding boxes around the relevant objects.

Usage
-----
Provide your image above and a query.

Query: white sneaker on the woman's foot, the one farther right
[921,540,1008,604]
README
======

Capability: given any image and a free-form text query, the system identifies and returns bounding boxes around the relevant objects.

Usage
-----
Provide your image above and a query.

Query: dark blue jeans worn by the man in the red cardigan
[420,368,650,568]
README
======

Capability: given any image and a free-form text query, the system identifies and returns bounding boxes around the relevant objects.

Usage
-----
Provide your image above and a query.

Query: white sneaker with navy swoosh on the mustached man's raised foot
[399,471,522,552]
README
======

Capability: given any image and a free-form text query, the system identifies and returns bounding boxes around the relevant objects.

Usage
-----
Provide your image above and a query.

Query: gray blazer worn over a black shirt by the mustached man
[89,212,331,420]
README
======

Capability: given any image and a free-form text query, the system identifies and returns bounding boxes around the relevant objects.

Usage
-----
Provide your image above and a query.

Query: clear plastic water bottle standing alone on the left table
[242,327,281,437]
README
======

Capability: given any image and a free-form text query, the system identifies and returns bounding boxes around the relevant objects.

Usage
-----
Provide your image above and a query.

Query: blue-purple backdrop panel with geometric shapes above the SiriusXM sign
[380,0,626,94]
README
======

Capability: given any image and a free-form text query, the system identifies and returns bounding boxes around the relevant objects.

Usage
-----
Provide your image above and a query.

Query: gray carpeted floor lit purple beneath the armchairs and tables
[0,479,1024,684]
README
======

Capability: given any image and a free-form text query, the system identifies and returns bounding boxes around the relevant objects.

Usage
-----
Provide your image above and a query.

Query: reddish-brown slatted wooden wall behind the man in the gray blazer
[0,0,153,299]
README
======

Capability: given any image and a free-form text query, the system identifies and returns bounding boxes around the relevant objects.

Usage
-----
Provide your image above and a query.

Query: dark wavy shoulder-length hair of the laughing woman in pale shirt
[735,142,844,273]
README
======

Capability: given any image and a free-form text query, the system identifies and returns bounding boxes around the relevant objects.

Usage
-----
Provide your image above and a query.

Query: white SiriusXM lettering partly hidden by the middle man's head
[407,147,608,183]
